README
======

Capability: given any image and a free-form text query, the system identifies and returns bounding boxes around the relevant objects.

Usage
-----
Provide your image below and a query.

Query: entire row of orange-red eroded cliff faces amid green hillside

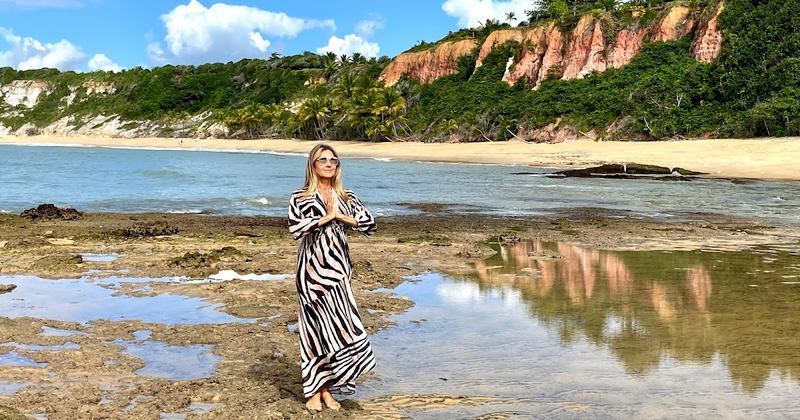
[381,3,724,89]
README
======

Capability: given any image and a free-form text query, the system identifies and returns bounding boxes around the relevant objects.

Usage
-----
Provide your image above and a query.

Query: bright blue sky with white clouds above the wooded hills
[0,0,535,72]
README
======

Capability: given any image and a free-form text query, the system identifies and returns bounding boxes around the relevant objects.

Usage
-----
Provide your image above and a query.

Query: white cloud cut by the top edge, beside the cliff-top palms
[442,0,538,27]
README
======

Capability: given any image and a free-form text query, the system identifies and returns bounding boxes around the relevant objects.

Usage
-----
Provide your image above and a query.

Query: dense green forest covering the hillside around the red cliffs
[0,0,800,141]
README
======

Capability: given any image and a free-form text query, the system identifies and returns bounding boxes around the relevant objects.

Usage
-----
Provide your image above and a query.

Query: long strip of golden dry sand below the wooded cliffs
[0,136,800,180]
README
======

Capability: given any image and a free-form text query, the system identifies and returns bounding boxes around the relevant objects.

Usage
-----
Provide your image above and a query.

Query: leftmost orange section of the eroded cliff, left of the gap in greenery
[380,39,477,86]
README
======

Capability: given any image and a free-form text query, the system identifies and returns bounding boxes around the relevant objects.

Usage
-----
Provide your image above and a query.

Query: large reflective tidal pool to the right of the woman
[366,241,800,418]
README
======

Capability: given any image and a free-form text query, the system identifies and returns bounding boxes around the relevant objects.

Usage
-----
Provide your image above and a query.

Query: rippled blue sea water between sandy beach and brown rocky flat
[0,145,800,223]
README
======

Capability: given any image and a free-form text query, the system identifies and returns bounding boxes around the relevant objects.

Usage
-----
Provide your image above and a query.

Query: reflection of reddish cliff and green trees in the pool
[468,241,800,391]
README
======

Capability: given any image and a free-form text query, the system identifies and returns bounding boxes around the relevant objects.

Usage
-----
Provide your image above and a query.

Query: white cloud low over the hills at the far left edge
[0,27,86,70]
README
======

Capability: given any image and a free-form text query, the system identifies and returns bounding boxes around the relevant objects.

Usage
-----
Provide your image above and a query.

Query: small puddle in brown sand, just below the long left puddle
[113,338,220,381]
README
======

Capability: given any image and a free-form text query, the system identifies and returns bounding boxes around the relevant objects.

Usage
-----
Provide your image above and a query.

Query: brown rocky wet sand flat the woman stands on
[0,209,800,419]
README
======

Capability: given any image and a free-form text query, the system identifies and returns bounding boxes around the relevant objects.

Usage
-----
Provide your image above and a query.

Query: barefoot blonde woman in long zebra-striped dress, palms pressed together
[289,144,375,411]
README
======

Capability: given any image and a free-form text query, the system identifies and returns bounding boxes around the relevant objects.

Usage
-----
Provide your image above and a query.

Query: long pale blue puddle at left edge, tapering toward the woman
[0,276,254,324]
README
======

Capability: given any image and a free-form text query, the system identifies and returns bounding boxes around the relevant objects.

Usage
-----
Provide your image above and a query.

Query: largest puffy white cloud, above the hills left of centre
[147,0,336,64]
